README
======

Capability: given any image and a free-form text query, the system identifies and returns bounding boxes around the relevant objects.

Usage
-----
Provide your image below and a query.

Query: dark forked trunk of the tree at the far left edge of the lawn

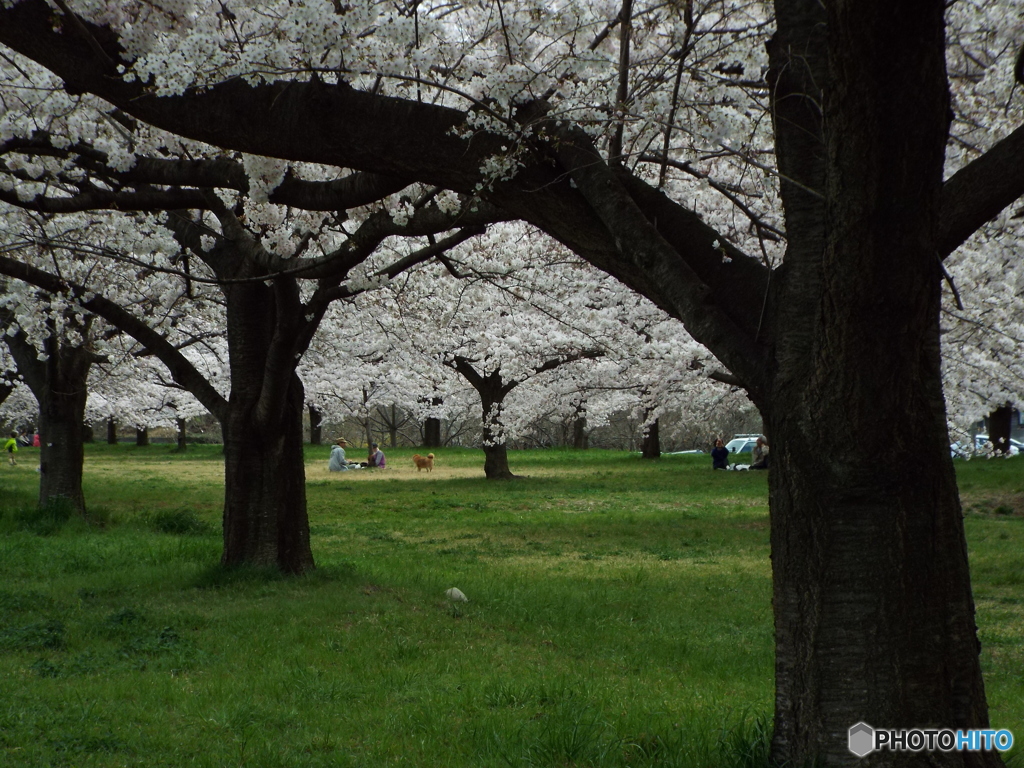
[6,330,97,514]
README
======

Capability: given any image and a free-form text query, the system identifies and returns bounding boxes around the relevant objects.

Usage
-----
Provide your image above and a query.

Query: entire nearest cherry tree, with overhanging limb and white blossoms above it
[0,0,1024,766]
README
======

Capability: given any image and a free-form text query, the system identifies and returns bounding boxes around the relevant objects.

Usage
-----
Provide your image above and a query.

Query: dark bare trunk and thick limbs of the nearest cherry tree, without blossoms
[0,0,1024,768]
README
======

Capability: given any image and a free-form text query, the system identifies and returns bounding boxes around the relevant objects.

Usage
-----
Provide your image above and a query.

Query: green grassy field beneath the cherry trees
[0,445,1024,768]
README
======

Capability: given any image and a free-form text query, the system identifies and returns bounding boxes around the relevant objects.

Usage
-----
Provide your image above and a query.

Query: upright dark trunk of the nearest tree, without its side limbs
[759,2,1001,766]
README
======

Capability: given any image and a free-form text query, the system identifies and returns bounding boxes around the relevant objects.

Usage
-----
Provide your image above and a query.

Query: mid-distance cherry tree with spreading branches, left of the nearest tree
[0,117,495,572]
